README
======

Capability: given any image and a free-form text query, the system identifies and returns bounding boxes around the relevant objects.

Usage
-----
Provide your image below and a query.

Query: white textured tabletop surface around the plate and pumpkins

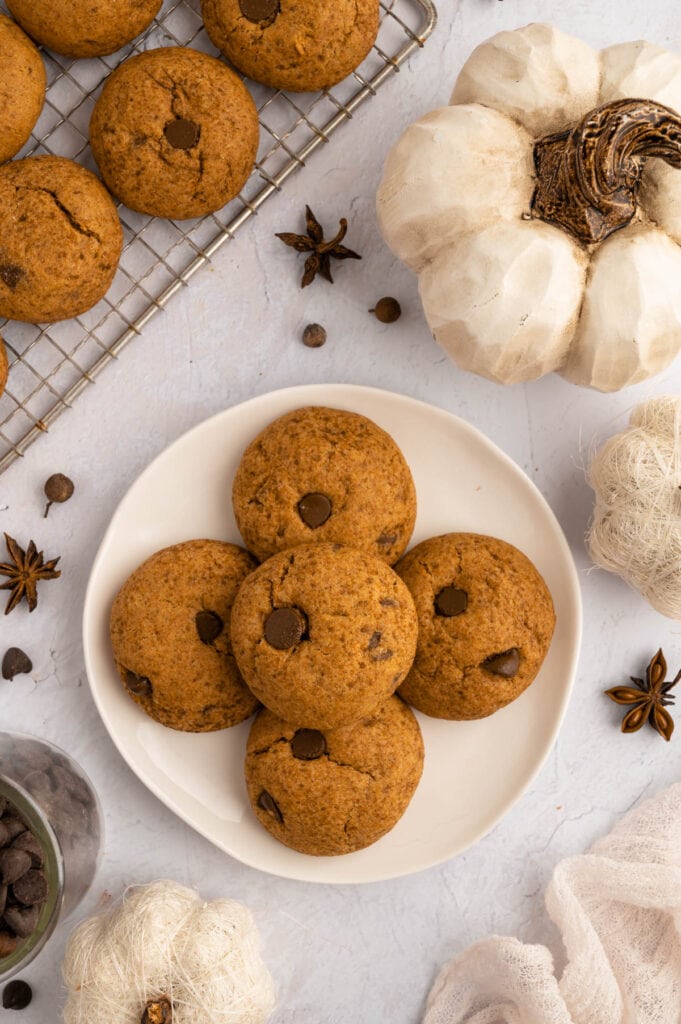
[0,0,681,1024]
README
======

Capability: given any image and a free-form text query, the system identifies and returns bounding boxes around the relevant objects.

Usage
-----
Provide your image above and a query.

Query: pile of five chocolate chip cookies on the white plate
[111,407,555,855]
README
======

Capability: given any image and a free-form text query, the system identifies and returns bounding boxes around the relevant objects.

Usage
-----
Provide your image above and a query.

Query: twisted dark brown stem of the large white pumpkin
[531,99,681,245]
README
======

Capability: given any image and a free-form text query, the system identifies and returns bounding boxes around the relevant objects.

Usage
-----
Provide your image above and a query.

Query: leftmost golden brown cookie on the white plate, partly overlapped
[111,541,258,732]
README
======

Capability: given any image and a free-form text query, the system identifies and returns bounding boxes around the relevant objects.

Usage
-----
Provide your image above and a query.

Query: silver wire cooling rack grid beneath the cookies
[0,0,436,473]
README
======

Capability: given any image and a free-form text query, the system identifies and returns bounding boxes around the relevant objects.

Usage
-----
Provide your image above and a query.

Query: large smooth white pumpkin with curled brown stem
[377,25,681,391]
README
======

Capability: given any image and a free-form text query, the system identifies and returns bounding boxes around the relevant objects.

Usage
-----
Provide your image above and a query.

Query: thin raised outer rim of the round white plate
[82,382,583,886]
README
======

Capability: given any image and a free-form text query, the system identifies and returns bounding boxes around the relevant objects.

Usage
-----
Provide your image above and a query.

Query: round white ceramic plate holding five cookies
[84,385,582,883]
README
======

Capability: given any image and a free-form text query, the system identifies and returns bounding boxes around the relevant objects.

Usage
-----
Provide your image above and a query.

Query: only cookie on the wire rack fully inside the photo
[90,46,259,220]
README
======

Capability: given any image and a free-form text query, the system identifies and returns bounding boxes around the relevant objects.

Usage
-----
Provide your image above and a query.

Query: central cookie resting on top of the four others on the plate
[231,544,417,729]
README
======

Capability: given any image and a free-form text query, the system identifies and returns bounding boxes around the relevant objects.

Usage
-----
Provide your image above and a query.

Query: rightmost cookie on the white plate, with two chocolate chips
[395,534,555,719]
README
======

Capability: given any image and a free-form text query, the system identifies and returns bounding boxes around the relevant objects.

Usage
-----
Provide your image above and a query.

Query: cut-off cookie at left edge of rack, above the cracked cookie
[0,14,45,163]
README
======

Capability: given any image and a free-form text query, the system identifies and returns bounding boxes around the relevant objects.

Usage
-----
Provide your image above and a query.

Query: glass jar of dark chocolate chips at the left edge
[0,732,101,983]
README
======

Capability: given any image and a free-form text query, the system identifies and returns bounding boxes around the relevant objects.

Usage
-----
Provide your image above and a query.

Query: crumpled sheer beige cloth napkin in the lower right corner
[423,783,681,1024]
